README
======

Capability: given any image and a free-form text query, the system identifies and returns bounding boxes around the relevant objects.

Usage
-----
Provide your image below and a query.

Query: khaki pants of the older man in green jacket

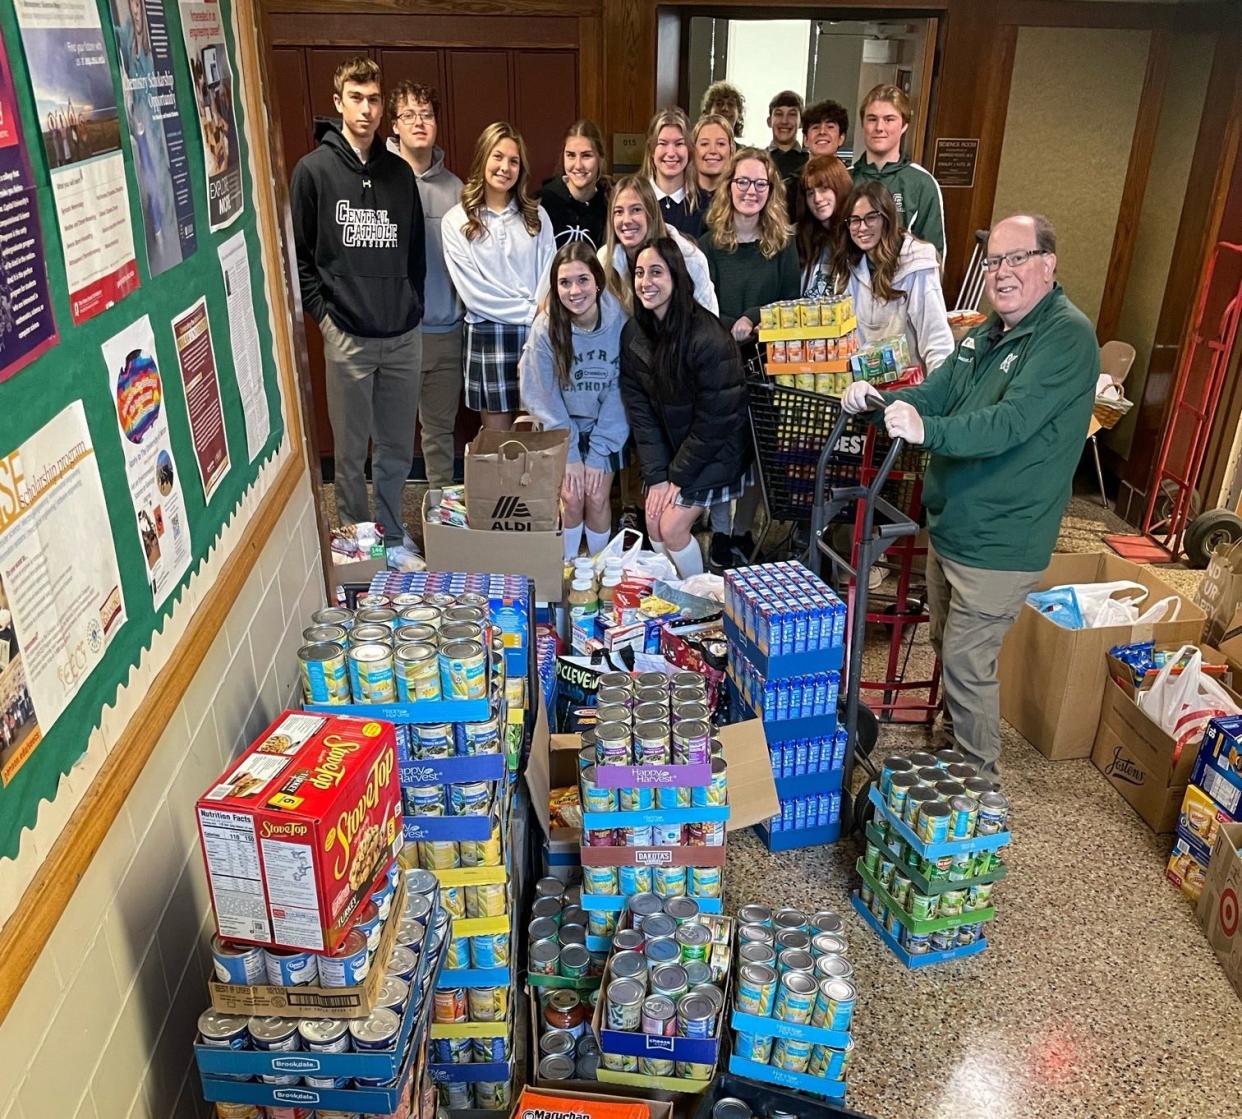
[927,545,1041,776]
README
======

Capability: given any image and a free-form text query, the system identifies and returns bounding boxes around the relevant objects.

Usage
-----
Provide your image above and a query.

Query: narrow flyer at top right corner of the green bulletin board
[180,0,246,232]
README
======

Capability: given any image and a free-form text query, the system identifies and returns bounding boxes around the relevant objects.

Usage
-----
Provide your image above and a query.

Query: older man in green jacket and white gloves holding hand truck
[842,215,1099,776]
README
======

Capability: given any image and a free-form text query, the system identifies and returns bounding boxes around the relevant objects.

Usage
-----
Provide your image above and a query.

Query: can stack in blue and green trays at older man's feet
[858,750,1009,955]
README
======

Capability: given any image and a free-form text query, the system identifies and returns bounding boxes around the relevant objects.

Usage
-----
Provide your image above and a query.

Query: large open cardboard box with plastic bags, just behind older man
[999,551,1206,760]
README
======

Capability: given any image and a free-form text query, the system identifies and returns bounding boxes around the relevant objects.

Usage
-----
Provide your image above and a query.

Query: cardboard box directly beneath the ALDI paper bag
[422,493,565,602]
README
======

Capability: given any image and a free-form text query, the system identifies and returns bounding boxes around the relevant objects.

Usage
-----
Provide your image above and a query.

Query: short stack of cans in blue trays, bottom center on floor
[733,904,858,1080]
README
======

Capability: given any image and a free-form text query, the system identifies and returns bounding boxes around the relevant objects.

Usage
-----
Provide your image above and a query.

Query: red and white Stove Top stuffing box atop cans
[196,712,401,951]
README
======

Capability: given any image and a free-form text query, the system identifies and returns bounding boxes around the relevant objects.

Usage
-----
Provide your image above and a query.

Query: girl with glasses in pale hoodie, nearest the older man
[833,179,953,373]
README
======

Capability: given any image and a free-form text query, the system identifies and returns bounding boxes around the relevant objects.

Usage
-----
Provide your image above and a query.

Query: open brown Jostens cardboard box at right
[1090,642,1242,833]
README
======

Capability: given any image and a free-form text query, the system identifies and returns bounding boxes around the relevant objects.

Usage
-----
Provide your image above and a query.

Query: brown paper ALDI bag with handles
[466,428,569,533]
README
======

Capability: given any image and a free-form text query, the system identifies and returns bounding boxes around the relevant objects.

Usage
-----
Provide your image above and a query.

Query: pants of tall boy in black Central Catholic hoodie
[319,317,422,545]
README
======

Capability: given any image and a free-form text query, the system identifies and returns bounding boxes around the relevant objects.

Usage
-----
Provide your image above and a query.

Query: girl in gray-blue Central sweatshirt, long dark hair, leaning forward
[518,241,630,559]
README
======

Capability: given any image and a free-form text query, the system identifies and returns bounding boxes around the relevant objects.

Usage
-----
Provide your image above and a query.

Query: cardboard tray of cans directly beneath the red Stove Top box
[211,866,402,987]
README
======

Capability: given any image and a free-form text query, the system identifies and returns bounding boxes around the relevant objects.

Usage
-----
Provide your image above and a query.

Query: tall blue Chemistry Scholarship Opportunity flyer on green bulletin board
[111,0,197,276]
